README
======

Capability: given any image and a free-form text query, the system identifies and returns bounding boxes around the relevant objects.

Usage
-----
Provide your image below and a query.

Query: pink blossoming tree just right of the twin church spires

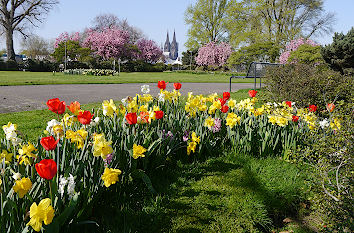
[195,42,232,66]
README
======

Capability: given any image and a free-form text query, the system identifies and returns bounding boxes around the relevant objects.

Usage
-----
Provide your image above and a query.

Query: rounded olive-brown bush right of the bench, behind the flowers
[264,64,353,108]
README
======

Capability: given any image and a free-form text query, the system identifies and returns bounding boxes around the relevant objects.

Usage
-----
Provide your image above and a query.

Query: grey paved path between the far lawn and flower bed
[0,83,253,113]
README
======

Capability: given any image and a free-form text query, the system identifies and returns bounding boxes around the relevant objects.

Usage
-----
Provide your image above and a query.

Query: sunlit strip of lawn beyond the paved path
[0,71,253,86]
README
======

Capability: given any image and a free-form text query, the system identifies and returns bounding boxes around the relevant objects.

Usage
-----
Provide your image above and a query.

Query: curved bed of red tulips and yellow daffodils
[0,81,340,232]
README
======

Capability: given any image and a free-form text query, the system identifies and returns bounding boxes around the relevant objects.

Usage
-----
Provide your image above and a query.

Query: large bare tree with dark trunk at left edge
[0,0,59,61]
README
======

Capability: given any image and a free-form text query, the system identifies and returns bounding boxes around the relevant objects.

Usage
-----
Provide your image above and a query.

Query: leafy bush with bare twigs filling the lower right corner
[293,101,354,232]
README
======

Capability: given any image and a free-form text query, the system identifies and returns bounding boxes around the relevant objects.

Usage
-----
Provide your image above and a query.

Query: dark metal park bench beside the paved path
[230,62,283,92]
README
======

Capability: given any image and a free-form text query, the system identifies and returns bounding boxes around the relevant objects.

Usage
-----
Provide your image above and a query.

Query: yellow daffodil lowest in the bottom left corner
[27,198,54,232]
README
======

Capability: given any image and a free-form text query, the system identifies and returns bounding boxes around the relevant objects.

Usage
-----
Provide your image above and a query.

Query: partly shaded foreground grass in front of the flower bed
[91,152,313,233]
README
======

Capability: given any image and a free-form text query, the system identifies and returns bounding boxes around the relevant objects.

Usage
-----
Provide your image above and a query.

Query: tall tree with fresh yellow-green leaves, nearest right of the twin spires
[185,0,229,49]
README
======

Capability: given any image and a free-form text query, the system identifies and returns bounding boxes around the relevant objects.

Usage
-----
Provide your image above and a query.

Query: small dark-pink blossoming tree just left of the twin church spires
[136,39,162,63]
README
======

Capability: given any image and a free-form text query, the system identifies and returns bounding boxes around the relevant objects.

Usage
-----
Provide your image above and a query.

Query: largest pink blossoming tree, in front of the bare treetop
[83,28,129,59]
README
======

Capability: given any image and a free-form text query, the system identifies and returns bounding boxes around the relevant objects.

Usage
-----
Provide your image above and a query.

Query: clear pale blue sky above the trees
[0,0,354,54]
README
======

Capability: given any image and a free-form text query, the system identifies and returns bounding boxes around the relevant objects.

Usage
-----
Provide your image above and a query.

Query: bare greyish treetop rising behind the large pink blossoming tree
[92,14,144,43]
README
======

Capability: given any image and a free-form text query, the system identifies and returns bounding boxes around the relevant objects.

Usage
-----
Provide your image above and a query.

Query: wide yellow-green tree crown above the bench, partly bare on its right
[226,0,334,46]
